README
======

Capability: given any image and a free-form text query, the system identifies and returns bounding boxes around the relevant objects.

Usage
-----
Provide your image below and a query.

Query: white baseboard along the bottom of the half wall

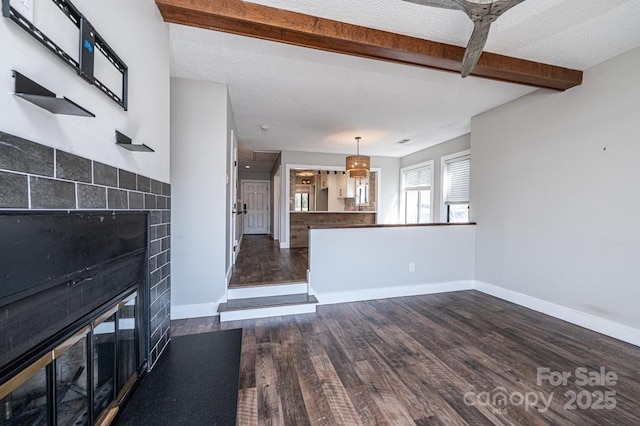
[315,280,474,305]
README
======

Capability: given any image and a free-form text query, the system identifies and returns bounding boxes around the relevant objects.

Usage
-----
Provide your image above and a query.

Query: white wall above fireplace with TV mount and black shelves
[0,0,169,182]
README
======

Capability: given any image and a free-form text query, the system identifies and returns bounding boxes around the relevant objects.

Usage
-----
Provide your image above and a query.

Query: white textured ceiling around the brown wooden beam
[171,0,640,170]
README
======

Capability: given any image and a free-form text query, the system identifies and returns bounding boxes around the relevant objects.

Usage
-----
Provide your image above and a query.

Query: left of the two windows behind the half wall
[401,161,433,223]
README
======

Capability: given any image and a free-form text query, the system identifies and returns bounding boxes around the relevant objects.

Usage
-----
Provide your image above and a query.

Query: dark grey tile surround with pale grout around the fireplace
[0,132,171,365]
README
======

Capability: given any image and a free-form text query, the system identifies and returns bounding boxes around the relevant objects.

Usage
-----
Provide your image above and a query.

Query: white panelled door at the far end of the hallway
[242,180,269,234]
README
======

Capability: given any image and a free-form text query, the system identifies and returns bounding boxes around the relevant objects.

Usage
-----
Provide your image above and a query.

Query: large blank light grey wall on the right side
[470,49,640,332]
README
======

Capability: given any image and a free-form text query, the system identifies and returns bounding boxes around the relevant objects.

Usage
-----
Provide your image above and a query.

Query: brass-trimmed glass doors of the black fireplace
[0,292,139,426]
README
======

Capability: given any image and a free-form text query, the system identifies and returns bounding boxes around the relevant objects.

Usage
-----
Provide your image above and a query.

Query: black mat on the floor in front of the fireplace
[115,329,242,426]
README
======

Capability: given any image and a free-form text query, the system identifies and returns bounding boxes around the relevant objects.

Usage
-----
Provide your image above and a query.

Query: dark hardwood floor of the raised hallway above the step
[229,235,309,288]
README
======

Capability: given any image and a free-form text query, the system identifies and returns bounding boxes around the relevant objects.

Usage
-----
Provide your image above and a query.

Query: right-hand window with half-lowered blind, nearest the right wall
[442,151,471,223]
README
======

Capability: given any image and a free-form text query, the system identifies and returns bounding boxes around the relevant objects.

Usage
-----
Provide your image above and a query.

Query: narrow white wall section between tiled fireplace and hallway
[171,78,231,318]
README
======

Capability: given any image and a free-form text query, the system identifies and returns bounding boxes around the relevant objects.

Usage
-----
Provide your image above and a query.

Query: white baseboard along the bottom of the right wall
[475,281,640,346]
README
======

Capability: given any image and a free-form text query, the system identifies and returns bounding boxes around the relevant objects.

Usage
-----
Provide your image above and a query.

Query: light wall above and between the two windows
[400,134,471,222]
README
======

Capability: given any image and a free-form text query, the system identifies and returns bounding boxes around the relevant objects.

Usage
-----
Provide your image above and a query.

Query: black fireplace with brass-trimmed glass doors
[0,212,149,426]
